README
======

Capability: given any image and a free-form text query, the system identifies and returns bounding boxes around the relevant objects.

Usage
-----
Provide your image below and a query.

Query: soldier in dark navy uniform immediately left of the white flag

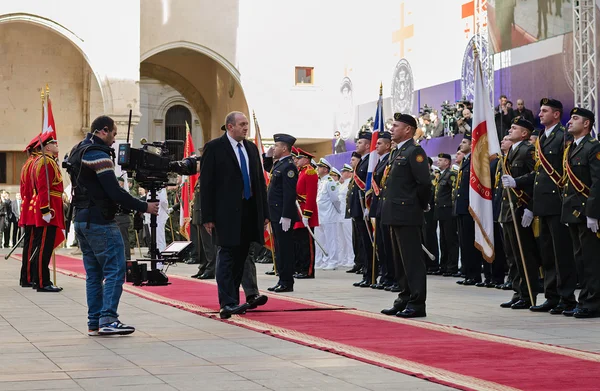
[453,133,483,286]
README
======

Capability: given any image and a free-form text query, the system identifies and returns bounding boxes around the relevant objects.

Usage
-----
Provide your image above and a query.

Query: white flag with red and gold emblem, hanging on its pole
[469,50,500,263]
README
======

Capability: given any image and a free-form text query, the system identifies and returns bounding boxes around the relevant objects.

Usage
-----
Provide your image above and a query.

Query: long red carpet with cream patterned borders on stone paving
[32,256,600,390]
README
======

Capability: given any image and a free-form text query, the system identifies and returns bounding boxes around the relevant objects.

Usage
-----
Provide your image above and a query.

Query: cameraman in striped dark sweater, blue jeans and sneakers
[68,116,158,336]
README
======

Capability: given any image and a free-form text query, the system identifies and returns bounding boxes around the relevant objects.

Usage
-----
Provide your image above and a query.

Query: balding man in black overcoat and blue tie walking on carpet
[200,111,269,319]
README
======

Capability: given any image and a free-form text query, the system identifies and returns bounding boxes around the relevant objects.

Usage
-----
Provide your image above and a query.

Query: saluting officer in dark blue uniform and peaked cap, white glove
[264,133,300,292]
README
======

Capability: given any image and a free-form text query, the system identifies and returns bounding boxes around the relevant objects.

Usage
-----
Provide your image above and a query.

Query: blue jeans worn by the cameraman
[75,222,126,329]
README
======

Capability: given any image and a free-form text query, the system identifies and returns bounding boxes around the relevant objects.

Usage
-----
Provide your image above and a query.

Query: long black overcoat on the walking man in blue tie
[200,133,269,247]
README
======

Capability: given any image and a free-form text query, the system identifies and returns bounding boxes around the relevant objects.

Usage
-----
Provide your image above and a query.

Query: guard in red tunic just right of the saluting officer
[292,148,319,279]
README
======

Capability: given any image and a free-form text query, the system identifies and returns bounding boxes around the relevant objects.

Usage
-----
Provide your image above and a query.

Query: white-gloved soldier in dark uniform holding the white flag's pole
[500,117,540,309]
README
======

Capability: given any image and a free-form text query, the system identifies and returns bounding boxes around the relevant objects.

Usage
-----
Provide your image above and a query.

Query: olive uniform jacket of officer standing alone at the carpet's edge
[381,138,431,226]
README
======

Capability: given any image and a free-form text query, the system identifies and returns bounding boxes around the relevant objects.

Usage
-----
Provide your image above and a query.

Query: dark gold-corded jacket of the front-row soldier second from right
[515,123,573,216]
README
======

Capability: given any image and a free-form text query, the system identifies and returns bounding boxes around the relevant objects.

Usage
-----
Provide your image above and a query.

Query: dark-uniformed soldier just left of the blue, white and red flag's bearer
[347,132,373,287]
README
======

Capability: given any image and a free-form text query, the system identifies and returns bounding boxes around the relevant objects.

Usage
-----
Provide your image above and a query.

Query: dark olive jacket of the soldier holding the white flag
[499,141,535,223]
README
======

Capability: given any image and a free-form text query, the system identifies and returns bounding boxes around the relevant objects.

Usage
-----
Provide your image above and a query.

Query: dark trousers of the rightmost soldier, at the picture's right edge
[569,223,600,312]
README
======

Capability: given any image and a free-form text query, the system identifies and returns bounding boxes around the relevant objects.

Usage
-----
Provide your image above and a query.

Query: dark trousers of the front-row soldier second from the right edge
[539,216,576,305]
